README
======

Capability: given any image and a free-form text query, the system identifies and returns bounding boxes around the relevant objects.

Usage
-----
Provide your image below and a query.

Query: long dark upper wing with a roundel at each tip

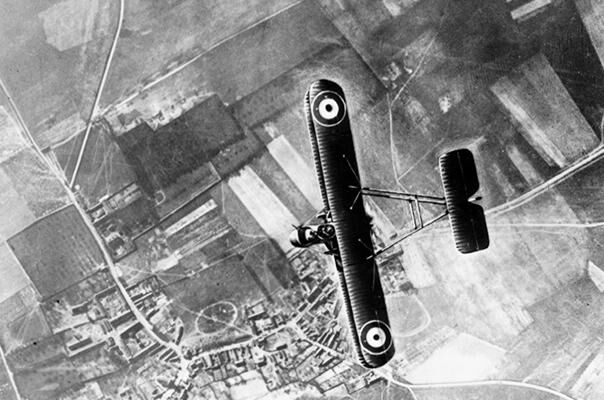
[305,80,394,367]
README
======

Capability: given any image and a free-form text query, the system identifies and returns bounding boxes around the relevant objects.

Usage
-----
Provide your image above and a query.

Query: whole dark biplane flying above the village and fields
[289,80,489,368]
